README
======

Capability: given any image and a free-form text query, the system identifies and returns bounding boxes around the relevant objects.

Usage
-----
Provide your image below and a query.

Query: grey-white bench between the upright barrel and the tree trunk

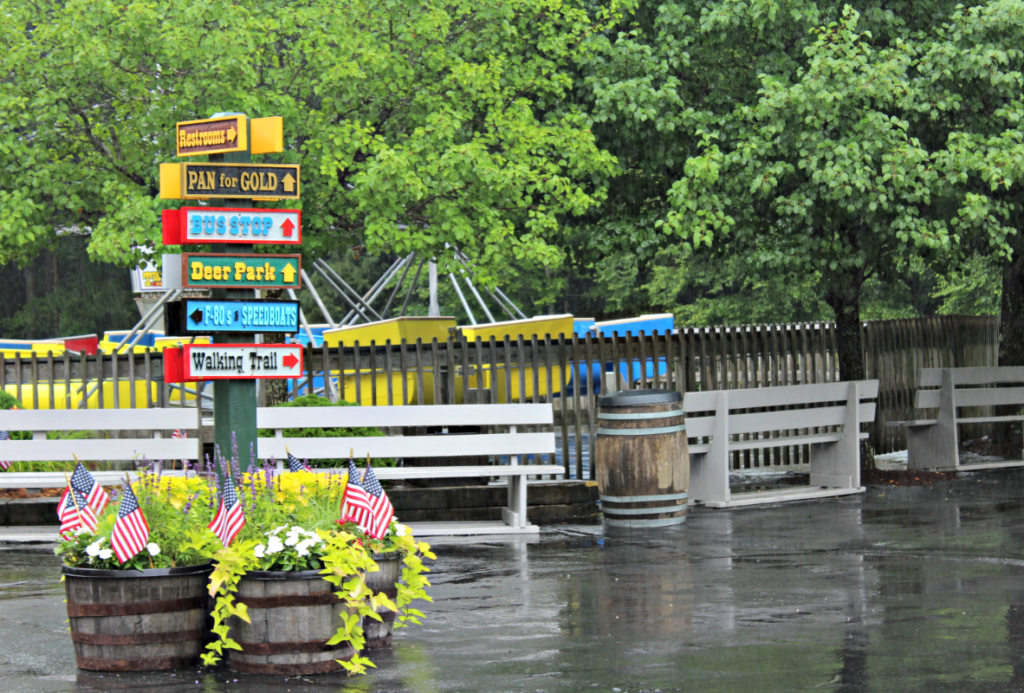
[683,380,879,508]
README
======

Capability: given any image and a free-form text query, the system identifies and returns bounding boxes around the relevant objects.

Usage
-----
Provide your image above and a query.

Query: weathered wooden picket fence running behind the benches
[0,316,998,478]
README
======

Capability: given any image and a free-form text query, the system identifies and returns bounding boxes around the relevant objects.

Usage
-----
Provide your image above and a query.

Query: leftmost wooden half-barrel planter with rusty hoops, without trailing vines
[63,564,213,672]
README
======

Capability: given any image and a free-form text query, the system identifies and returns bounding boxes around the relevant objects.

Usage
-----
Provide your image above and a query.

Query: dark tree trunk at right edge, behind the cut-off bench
[992,250,1024,459]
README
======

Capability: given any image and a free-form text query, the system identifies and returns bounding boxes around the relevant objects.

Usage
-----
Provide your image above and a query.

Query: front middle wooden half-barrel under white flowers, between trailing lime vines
[226,570,355,676]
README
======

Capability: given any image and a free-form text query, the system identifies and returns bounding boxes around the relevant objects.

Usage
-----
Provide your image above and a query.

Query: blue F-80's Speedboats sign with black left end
[164,299,299,337]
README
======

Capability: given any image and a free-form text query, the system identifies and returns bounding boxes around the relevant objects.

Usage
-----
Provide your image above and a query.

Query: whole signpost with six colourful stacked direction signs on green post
[160,114,302,468]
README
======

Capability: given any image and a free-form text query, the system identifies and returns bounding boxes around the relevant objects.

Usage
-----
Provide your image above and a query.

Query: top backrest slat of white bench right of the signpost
[254,404,554,429]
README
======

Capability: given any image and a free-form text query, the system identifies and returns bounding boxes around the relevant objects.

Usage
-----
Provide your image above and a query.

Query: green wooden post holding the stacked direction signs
[210,113,259,471]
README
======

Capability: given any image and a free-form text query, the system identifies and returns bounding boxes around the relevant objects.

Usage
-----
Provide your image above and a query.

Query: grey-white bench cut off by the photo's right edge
[886,365,1024,471]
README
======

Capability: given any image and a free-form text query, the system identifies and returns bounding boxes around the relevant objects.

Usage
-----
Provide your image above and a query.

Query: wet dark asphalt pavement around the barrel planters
[6,470,1024,693]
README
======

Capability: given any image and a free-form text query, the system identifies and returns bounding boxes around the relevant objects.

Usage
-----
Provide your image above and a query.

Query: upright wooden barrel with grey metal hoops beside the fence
[594,390,690,527]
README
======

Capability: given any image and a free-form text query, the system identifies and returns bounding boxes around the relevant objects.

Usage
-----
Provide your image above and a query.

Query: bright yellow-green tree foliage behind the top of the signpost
[0,0,618,280]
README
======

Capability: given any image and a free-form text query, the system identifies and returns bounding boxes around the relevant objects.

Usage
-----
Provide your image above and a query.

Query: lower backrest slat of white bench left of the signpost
[0,438,198,462]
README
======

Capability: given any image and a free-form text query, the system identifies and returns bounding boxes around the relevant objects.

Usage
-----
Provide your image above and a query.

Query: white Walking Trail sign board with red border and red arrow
[182,344,302,380]
